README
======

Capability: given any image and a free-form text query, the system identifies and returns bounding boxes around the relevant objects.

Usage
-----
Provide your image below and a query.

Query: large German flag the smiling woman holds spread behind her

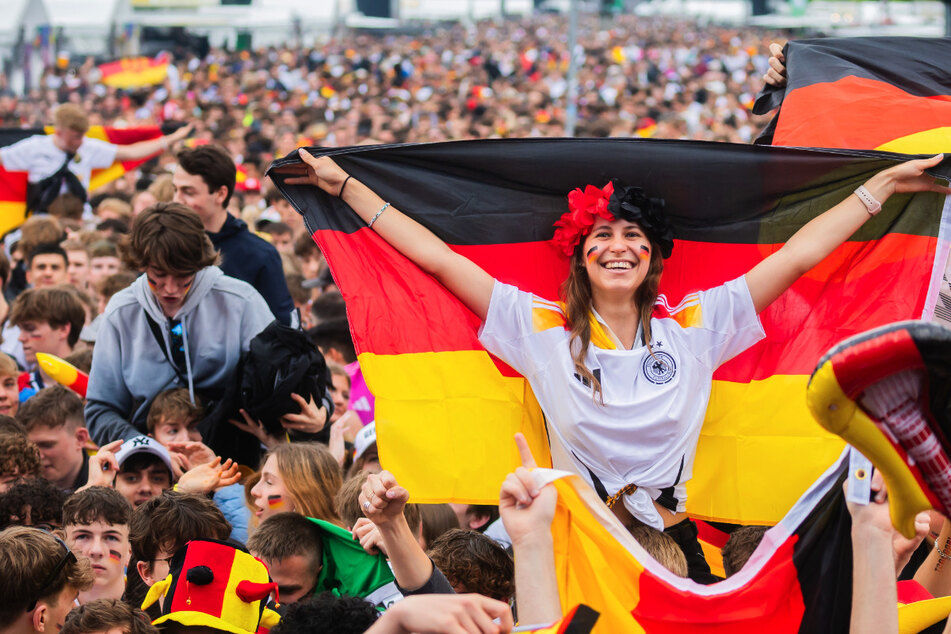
[269,139,951,524]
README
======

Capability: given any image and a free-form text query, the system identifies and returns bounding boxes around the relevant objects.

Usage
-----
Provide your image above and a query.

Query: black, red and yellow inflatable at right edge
[806,321,951,539]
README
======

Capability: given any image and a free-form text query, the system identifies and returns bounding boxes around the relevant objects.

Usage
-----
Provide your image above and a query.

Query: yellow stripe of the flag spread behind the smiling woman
[359,351,843,524]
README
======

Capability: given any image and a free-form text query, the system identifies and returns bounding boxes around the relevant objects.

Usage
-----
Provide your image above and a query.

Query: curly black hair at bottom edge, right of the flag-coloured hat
[271,592,379,634]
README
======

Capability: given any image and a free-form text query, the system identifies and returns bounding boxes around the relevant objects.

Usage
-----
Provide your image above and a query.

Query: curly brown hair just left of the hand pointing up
[428,528,515,601]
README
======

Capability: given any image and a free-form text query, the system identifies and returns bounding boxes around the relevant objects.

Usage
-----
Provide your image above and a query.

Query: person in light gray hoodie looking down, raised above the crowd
[86,203,274,445]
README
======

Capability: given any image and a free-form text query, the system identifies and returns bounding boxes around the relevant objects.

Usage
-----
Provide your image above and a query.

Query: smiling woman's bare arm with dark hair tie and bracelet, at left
[286,150,495,321]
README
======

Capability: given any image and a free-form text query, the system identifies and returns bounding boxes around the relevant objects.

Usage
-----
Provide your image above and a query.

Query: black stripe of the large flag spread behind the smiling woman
[266,138,951,246]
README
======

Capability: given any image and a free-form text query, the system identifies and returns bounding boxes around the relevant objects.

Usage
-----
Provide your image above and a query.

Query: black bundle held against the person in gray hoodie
[238,321,330,435]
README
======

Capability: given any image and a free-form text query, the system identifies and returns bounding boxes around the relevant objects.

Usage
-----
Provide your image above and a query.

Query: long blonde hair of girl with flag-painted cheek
[265,442,343,525]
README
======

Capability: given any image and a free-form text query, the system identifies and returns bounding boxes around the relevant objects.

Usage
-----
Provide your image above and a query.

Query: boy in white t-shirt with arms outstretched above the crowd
[0,103,191,211]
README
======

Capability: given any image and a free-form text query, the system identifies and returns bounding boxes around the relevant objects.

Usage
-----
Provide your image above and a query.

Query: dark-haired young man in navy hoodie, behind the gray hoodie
[172,145,299,327]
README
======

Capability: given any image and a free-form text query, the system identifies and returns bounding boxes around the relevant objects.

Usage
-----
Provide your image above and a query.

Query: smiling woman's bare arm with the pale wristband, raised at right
[746,154,951,313]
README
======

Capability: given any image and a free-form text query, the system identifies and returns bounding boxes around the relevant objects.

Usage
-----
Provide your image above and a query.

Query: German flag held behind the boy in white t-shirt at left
[0,126,162,235]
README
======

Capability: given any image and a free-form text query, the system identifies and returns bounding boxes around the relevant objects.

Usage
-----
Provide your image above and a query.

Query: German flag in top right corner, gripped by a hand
[753,37,951,154]
